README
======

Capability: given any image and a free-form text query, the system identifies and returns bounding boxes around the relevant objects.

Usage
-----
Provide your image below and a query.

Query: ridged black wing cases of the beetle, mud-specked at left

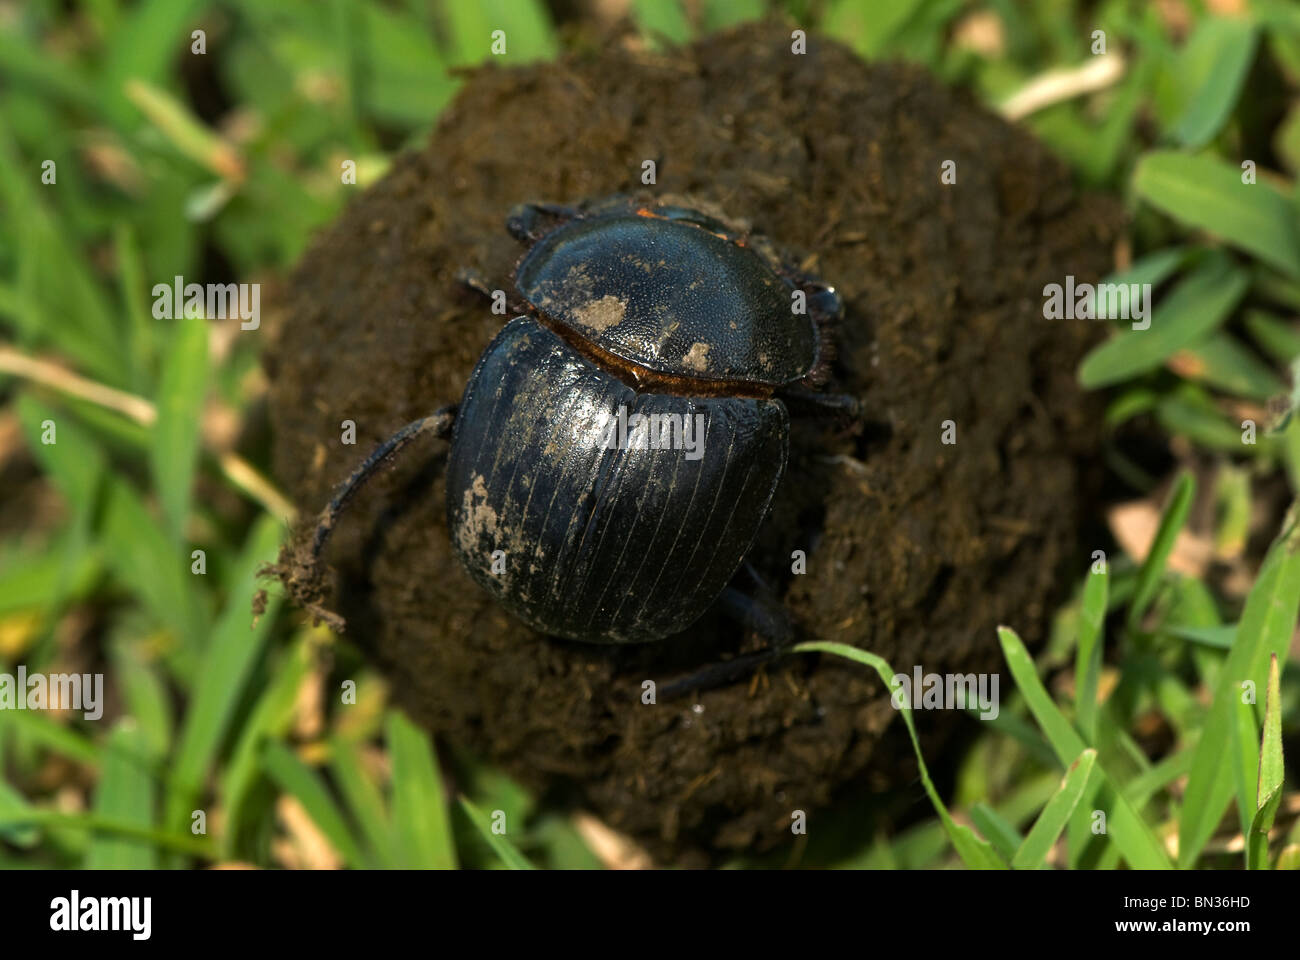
[447,317,789,643]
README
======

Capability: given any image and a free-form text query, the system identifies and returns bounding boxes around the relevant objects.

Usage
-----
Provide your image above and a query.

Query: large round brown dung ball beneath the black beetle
[265,23,1119,865]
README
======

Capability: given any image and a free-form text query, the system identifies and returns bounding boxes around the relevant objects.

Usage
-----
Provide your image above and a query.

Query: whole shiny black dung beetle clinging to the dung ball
[290,195,857,681]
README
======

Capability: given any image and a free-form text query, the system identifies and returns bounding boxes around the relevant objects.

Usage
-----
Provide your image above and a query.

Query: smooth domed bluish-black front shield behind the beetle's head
[515,206,816,386]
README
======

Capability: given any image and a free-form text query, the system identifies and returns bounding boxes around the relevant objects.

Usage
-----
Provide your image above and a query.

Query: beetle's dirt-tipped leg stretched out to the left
[261,406,456,631]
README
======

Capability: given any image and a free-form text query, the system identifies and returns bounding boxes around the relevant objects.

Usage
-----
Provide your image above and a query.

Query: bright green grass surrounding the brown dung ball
[0,0,1300,869]
